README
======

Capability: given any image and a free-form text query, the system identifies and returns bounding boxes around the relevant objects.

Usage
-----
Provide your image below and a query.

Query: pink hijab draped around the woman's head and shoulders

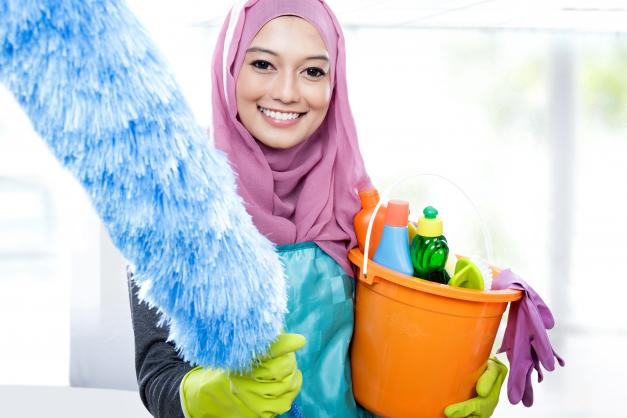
[212,0,372,275]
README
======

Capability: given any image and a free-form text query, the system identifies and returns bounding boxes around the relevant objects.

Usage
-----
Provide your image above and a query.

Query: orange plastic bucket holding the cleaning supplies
[348,248,522,418]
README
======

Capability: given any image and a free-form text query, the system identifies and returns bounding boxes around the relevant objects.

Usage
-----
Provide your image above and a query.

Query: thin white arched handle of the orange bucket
[361,173,492,284]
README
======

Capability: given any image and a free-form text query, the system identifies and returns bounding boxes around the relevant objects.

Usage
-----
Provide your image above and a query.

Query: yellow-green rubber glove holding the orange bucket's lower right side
[444,356,507,418]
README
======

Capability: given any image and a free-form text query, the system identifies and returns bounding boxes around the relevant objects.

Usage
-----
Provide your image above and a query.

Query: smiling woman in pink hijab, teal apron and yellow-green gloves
[133,0,504,418]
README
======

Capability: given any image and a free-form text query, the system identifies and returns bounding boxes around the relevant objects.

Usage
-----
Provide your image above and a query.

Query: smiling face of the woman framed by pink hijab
[235,16,331,148]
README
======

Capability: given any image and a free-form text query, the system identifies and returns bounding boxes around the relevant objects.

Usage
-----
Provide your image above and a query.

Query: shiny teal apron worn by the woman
[277,242,370,418]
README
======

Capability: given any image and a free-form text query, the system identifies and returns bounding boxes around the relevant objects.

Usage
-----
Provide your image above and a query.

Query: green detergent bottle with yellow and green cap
[411,206,450,284]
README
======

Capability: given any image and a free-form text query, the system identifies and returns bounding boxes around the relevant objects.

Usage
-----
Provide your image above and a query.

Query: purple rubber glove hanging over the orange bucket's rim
[492,269,565,406]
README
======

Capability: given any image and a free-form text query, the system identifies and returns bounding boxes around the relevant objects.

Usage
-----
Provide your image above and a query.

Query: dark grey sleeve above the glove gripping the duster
[127,272,192,418]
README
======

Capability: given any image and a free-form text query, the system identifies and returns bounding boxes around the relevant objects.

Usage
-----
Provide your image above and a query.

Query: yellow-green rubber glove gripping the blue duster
[179,334,306,418]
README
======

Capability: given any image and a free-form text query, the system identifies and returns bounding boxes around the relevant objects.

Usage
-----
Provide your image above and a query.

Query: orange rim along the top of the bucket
[348,247,523,303]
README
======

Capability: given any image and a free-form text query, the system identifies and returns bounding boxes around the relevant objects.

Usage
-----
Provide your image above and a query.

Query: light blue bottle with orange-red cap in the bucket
[372,200,414,276]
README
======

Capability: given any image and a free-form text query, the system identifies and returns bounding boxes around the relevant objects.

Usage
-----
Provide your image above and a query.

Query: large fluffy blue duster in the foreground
[0,0,286,376]
